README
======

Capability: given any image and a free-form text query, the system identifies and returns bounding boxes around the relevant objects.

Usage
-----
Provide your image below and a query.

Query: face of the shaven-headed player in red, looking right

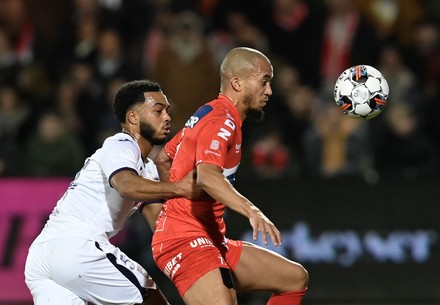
[244,59,273,121]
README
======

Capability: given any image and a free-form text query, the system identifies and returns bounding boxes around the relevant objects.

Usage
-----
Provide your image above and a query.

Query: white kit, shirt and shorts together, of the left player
[25,133,161,305]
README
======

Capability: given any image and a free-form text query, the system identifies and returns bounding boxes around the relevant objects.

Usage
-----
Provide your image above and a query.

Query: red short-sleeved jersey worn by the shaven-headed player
[154,95,243,242]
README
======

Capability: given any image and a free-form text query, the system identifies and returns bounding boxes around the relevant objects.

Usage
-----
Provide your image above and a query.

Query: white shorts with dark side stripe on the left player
[25,238,156,305]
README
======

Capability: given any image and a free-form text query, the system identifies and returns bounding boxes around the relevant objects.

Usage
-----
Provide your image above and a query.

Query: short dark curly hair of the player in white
[113,80,161,123]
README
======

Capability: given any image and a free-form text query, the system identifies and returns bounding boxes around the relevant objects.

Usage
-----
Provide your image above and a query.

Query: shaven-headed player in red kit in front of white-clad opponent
[152,48,308,305]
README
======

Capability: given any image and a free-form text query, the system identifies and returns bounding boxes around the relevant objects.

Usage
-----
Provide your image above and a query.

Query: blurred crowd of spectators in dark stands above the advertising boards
[0,0,440,183]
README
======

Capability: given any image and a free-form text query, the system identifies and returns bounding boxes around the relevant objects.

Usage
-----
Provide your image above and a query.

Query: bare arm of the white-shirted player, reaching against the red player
[110,170,200,202]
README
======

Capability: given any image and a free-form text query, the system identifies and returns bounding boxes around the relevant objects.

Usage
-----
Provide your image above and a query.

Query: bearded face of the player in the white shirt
[138,92,171,145]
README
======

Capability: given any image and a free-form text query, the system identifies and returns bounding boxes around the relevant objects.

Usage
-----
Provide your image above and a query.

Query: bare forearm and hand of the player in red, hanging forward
[197,163,282,245]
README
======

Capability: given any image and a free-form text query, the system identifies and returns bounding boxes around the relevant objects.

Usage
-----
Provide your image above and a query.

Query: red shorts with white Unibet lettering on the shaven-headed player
[152,235,243,297]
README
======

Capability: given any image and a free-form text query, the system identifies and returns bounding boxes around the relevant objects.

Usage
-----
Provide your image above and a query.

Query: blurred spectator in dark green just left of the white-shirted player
[23,112,84,177]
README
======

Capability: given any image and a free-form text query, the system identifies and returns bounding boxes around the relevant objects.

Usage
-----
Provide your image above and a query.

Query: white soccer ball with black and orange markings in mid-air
[334,65,390,120]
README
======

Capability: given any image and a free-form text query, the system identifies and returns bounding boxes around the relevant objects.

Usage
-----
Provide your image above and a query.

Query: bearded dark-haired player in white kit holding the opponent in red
[25,80,199,305]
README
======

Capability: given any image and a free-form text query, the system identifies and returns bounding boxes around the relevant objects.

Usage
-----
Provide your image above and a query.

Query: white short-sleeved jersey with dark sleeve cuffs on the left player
[35,133,161,243]
